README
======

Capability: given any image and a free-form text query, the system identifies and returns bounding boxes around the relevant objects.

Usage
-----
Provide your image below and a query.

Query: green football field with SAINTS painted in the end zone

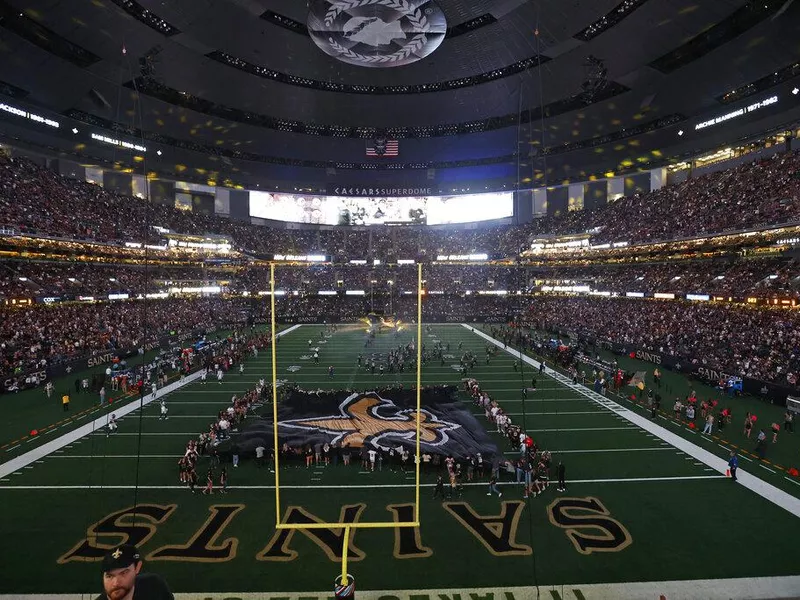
[0,324,800,600]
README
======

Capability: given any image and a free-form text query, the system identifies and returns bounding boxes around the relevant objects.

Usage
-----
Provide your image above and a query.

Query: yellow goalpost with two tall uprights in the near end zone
[269,262,425,598]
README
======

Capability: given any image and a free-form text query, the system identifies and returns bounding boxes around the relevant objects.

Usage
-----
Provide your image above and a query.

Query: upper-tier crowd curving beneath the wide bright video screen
[0,152,800,261]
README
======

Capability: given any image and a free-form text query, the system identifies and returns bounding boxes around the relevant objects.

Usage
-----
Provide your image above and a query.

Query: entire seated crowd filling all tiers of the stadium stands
[0,152,800,394]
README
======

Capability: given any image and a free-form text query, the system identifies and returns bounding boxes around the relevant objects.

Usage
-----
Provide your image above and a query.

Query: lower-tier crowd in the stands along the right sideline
[528,296,800,385]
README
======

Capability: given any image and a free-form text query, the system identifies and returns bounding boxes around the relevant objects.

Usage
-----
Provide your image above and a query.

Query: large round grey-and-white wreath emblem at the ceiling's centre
[308,0,447,68]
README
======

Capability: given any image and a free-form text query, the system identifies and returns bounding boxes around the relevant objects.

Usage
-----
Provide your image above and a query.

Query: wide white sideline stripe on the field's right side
[461,323,800,517]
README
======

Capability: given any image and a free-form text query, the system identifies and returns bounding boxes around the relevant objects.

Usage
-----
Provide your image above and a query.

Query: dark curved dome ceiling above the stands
[0,0,800,186]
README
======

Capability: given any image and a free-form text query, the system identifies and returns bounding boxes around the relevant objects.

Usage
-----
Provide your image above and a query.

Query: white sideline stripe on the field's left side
[0,325,301,479]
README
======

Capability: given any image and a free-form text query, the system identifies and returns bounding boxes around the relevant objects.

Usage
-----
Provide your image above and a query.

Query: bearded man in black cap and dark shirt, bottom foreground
[96,544,175,600]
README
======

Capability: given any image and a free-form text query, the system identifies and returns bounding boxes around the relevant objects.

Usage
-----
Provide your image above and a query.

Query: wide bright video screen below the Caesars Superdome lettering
[250,192,514,225]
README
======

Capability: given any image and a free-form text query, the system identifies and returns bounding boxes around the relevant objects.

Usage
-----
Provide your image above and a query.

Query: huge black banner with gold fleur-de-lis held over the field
[227,386,497,457]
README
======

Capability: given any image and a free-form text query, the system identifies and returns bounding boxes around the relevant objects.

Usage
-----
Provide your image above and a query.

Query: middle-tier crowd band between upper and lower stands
[0,256,800,298]
